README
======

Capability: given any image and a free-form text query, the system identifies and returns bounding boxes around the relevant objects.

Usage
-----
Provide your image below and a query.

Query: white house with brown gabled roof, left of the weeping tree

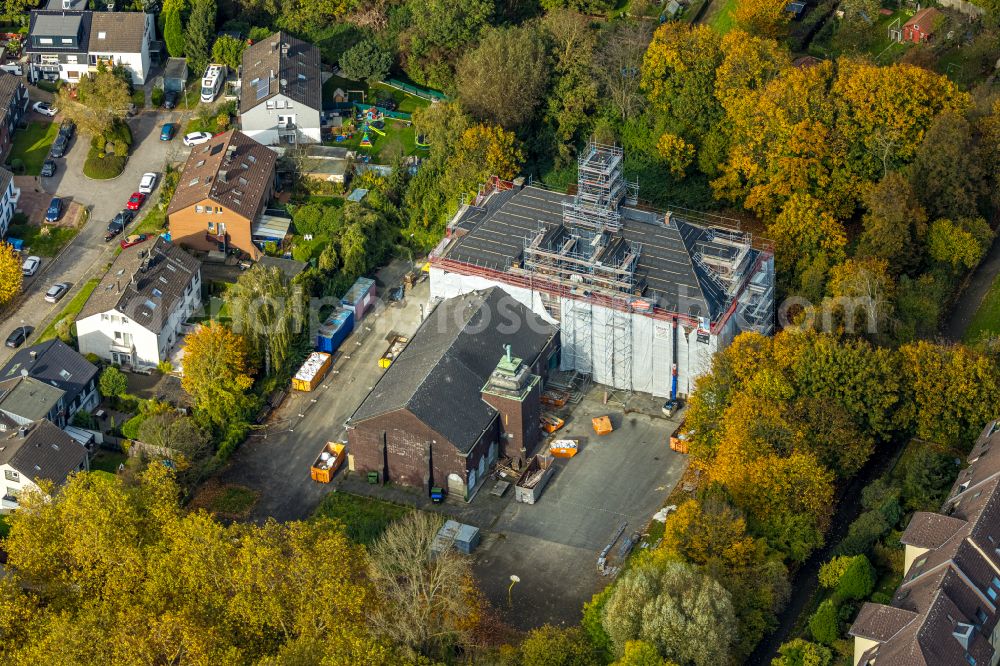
[76,237,201,369]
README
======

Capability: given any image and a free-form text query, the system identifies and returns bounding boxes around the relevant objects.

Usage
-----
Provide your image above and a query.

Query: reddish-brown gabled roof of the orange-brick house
[167,130,277,222]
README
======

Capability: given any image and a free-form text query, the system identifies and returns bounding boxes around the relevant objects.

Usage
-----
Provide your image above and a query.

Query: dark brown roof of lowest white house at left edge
[0,420,87,485]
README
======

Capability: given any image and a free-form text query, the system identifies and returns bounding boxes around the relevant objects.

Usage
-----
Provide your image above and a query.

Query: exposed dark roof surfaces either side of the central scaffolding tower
[445,186,757,321]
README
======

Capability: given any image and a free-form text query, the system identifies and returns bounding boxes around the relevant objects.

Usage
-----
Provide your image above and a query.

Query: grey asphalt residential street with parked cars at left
[0,112,187,365]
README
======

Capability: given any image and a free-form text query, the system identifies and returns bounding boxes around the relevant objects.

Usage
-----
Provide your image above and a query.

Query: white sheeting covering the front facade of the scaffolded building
[430,266,724,397]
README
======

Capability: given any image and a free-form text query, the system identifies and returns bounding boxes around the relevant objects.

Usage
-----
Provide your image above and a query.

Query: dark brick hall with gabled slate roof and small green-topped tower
[347,287,559,500]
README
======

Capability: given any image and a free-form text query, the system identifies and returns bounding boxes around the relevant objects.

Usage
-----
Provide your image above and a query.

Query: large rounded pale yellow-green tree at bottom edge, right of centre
[604,557,736,666]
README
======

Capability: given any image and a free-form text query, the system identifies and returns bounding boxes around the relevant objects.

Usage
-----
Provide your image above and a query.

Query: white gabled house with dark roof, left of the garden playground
[240,32,323,145]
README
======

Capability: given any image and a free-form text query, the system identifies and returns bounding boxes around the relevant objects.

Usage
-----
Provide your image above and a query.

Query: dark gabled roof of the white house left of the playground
[240,32,323,113]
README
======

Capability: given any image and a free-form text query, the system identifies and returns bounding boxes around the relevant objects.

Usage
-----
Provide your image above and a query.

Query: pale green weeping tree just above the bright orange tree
[226,264,304,376]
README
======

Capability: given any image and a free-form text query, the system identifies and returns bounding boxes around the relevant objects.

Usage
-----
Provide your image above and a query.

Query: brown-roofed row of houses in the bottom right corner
[850,421,1000,666]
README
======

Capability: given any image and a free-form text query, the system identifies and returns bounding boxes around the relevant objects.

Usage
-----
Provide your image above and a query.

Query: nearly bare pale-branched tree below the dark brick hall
[368,511,482,656]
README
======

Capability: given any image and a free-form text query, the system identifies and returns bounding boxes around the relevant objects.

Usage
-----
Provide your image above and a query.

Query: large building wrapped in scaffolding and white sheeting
[430,143,774,396]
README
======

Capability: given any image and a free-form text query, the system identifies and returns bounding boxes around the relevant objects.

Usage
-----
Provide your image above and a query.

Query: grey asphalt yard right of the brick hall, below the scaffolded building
[473,386,687,629]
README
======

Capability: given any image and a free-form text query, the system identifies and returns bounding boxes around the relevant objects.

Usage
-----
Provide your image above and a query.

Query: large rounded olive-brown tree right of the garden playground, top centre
[457,26,549,129]
